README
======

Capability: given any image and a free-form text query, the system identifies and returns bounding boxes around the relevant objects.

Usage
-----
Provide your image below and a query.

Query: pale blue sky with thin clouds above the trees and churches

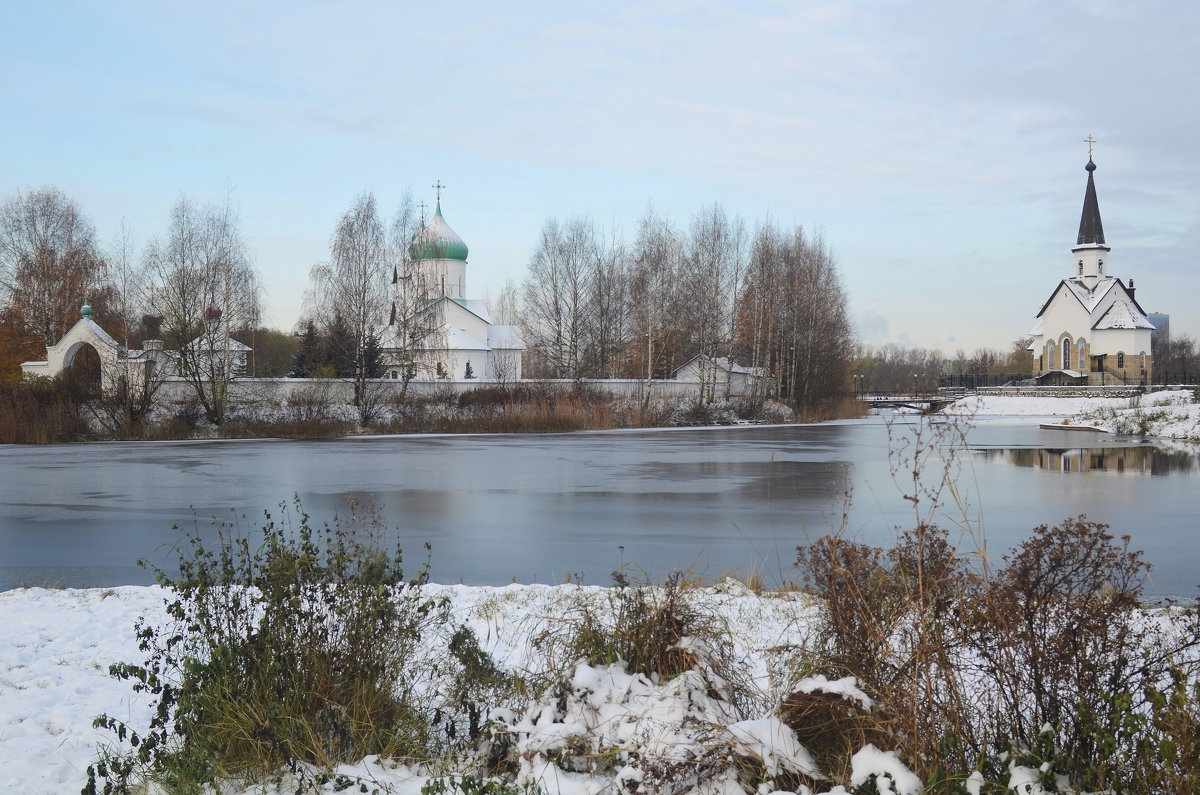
[0,0,1200,354]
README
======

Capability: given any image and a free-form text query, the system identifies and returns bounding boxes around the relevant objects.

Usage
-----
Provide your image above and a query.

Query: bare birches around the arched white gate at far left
[0,187,262,423]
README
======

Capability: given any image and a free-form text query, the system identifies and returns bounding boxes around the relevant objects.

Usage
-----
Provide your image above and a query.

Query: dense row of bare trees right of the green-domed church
[521,203,853,406]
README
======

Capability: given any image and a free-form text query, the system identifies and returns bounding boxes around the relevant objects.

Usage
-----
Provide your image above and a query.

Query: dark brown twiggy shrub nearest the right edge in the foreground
[972,516,1198,789]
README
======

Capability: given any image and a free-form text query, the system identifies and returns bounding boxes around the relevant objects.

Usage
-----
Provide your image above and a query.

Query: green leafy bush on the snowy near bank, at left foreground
[84,501,448,793]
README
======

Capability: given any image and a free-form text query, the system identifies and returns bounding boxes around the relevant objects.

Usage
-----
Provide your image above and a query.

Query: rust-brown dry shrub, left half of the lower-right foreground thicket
[797,525,978,778]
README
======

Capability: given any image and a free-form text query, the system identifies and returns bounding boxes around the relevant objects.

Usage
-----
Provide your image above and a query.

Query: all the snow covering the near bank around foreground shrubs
[7,580,1190,795]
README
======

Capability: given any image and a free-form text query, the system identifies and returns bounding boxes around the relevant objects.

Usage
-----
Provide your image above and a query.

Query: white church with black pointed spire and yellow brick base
[1030,154,1154,385]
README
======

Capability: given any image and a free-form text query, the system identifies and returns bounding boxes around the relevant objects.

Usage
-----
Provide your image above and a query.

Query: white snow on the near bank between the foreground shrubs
[0,581,916,795]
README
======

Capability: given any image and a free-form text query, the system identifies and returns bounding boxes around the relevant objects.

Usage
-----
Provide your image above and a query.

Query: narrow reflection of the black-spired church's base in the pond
[977,444,1200,476]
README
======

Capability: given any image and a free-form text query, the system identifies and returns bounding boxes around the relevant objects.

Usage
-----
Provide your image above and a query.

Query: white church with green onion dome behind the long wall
[379,197,526,381]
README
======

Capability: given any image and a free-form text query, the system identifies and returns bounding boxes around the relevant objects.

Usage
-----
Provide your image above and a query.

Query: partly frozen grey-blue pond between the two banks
[0,418,1200,597]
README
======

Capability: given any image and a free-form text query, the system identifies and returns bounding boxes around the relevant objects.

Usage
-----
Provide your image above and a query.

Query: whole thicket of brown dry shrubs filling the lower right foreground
[785,516,1200,791]
